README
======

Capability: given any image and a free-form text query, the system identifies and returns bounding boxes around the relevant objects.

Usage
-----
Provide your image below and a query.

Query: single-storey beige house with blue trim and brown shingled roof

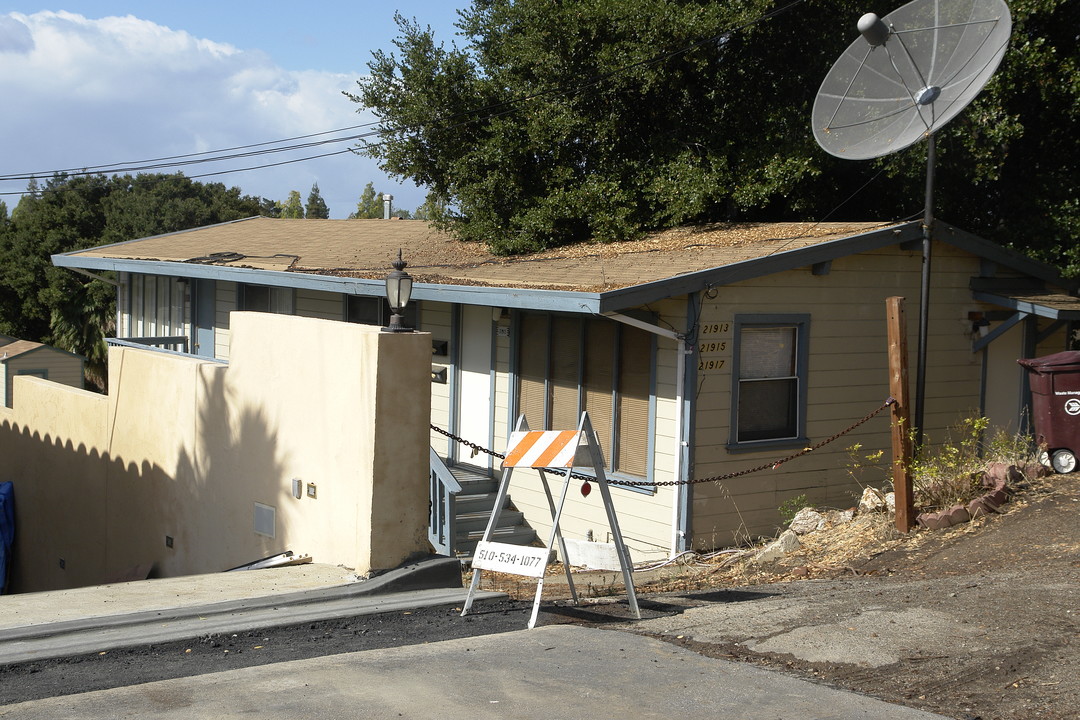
[53,218,1080,560]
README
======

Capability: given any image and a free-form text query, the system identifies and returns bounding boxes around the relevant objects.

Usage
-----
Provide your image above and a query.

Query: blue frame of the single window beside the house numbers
[727,313,810,452]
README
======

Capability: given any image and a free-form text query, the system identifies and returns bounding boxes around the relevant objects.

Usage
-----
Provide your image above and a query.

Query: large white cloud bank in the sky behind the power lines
[0,12,423,217]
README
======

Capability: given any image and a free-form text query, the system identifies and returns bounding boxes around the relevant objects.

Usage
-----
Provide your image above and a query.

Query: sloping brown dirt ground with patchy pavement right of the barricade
[481,473,1080,720]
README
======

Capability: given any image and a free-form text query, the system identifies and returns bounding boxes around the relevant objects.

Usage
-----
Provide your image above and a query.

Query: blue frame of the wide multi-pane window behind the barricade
[510,311,657,495]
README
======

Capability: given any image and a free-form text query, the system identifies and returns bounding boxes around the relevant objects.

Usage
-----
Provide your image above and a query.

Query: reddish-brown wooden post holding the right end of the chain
[885,297,915,532]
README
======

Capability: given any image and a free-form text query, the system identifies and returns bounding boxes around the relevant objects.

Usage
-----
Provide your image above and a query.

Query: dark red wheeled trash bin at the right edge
[1016,350,1080,473]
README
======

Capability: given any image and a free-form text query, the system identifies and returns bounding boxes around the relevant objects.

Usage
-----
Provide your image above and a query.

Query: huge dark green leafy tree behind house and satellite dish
[349,0,1080,267]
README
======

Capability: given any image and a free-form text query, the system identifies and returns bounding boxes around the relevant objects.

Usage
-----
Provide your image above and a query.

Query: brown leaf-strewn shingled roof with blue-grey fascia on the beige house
[53,218,1071,312]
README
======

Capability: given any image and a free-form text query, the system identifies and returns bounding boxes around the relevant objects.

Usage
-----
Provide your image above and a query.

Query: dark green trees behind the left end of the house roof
[0,173,267,385]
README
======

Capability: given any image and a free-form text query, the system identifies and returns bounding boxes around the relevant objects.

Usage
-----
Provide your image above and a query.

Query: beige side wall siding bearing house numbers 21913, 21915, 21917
[693,244,1019,547]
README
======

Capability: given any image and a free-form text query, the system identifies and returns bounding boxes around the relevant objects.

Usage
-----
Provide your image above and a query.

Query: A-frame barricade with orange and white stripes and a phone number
[461,412,642,628]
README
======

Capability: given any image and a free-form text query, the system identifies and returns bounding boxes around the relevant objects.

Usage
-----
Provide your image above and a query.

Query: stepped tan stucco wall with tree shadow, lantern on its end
[0,313,431,592]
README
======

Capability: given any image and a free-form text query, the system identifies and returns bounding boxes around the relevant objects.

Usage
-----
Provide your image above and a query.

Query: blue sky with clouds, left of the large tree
[0,0,470,218]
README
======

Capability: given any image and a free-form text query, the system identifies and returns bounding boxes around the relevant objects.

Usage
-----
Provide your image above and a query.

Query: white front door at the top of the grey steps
[455,305,494,467]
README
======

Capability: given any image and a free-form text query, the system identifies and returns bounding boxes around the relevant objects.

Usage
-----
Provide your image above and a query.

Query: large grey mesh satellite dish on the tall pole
[811,0,1012,160]
